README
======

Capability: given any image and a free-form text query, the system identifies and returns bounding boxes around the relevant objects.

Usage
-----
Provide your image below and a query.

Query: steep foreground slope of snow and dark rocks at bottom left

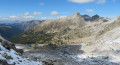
[0,36,42,65]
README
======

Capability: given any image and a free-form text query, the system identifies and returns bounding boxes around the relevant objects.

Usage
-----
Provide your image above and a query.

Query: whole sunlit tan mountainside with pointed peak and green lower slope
[11,12,116,44]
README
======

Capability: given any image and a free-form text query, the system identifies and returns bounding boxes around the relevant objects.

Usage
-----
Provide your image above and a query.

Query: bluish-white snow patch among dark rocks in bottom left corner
[0,45,42,65]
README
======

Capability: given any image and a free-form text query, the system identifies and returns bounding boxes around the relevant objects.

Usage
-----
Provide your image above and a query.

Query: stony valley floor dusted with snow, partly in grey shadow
[17,44,120,65]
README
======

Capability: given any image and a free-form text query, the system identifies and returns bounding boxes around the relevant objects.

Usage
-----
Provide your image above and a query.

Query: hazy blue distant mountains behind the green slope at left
[0,20,42,39]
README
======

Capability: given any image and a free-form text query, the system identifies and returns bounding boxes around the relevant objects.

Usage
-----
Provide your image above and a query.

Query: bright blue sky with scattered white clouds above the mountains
[0,0,120,20]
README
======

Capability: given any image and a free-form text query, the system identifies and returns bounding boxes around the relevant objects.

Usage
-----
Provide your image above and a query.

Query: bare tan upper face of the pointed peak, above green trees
[33,12,85,32]
